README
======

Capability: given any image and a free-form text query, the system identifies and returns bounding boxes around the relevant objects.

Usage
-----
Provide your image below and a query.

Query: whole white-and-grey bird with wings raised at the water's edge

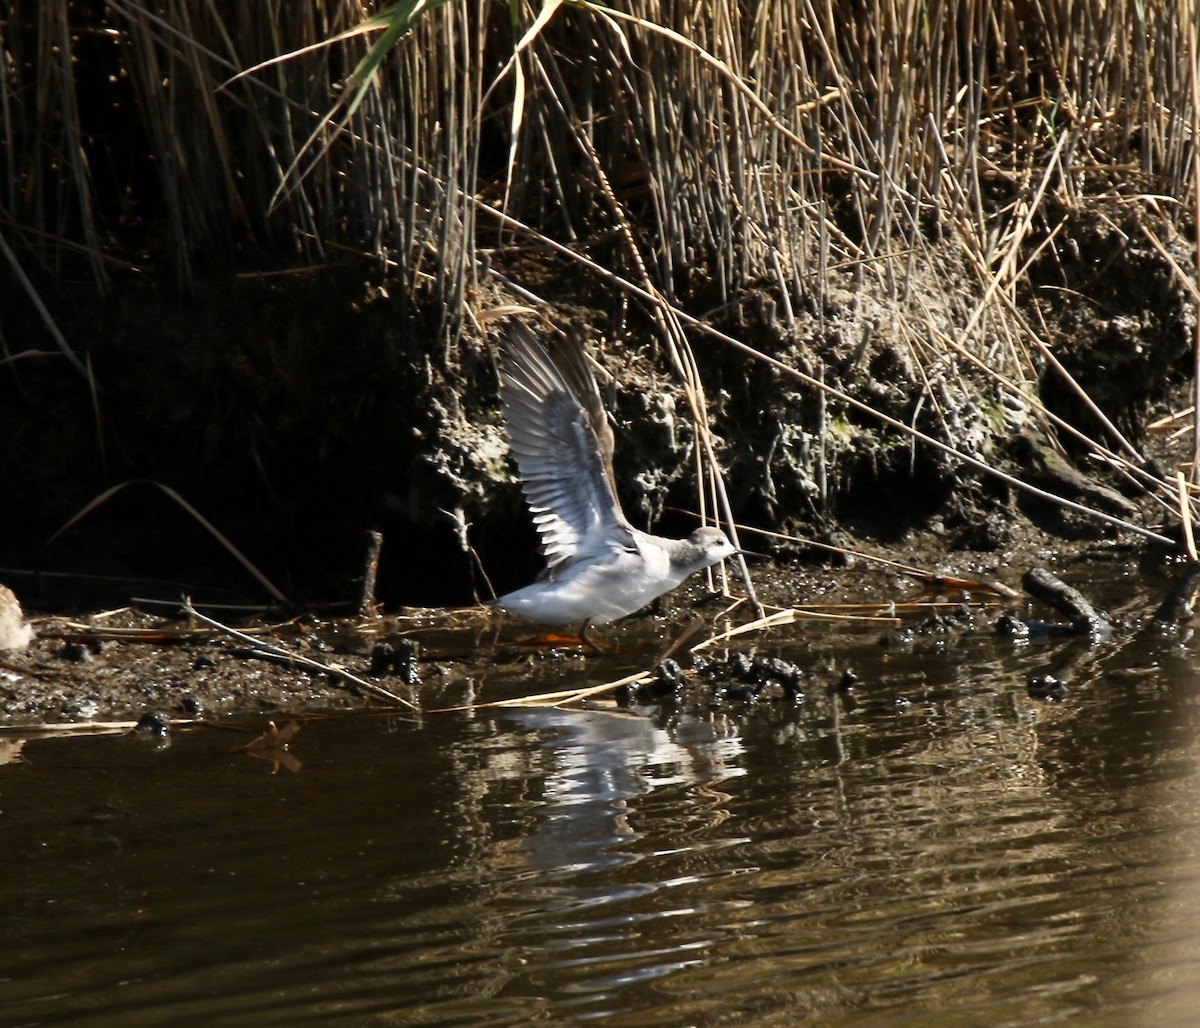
[491,321,738,629]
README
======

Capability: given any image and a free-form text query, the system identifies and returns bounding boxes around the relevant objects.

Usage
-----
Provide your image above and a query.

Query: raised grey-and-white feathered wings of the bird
[500,321,636,572]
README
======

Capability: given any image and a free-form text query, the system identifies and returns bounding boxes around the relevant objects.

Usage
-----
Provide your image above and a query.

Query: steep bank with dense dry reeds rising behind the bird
[0,4,1196,719]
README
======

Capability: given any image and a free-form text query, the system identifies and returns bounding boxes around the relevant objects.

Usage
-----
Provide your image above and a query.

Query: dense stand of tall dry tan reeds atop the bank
[0,0,1200,549]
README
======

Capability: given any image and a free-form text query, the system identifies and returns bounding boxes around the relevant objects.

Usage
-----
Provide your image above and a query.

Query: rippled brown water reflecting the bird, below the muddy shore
[0,566,1200,1026]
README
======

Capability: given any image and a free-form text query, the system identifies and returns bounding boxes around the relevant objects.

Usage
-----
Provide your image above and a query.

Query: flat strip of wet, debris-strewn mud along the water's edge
[0,518,1194,735]
